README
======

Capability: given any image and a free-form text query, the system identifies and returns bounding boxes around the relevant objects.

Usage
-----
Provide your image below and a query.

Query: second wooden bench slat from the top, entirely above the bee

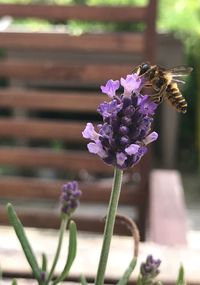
[0,32,144,53]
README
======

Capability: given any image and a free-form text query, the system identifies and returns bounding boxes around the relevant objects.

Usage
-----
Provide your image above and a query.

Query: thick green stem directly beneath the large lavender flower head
[95,168,123,285]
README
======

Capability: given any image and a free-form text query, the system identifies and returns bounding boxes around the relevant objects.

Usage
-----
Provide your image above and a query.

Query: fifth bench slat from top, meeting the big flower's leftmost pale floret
[0,118,86,142]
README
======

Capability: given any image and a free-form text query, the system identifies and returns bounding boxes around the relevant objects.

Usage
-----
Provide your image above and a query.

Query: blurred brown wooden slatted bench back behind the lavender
[0,0,159,239]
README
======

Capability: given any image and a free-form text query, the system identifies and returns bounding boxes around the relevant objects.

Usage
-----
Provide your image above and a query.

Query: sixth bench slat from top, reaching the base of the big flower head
[0,147,113,173]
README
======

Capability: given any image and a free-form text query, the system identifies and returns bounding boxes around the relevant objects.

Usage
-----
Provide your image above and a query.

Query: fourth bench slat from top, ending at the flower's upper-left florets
[0,87,108,113]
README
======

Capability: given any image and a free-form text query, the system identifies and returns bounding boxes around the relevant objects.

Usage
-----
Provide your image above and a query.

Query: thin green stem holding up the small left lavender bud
[46,216,68,284]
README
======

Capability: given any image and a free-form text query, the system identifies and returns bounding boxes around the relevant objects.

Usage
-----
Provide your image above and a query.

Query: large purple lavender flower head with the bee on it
[83,70,158,169]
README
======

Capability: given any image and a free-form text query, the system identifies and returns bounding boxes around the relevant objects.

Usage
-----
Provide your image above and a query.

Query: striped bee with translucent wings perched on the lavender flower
[133,62,192,113]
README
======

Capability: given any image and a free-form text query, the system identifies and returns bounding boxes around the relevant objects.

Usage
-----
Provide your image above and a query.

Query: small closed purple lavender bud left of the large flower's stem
[60,181,81,216]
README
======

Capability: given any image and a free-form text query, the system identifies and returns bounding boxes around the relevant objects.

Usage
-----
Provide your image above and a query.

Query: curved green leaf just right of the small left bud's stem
[53,221,77,285]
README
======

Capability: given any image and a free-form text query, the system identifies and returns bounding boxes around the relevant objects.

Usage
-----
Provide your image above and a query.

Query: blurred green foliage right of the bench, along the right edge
[158,0,200,171]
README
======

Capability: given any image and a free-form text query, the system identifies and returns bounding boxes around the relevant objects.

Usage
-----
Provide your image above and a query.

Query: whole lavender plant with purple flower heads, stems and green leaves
[7,69,188,285]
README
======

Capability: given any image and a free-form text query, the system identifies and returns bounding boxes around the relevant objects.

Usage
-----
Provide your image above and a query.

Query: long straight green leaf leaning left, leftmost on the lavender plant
[7,203,41,281]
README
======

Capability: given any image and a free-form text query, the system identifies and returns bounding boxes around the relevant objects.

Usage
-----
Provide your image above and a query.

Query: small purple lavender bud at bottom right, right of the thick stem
[140,255,161,278]
